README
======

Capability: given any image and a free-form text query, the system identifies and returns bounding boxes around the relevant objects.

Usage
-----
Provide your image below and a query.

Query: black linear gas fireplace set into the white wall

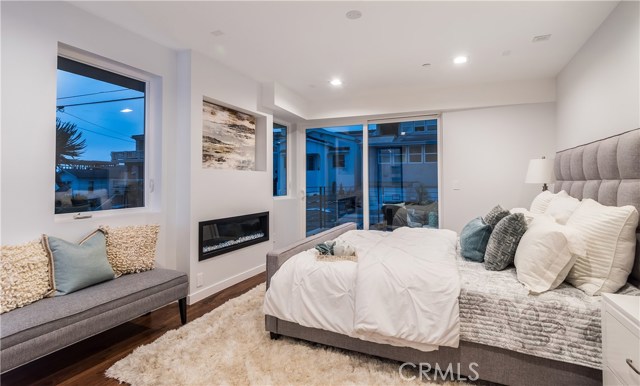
[198,212,269,261]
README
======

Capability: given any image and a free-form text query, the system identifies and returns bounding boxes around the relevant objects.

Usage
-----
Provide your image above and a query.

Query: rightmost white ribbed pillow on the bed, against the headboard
[567,199,638,295]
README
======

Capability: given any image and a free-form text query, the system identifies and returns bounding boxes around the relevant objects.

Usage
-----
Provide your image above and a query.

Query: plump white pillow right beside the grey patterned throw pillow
[514,215,586,293]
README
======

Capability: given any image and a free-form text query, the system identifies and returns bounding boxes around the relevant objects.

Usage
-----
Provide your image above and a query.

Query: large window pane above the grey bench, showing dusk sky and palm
[55,57,146,213]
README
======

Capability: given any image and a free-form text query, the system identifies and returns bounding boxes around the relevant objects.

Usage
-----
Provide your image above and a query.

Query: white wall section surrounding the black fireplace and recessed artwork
[177,51,273,303]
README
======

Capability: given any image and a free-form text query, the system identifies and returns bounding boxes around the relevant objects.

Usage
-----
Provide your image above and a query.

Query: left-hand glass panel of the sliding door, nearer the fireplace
[306,125,364,236]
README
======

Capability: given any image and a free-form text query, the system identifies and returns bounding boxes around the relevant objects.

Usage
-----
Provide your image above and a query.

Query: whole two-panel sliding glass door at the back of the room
[305,116,439,236]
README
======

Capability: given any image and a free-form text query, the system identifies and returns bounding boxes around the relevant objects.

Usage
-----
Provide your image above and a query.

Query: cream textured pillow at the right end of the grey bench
[100,225,160,276]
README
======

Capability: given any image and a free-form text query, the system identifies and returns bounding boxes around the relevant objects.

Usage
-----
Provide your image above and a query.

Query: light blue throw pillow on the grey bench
[43,231,115,296]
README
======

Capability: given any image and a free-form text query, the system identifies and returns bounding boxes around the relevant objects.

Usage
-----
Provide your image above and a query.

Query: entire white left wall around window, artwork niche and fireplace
[0,2,284,303]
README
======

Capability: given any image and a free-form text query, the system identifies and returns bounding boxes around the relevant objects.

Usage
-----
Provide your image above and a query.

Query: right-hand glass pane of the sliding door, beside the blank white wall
[368,119,438,229]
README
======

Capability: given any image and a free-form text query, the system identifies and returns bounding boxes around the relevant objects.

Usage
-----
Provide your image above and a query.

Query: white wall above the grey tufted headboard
[557,1,640,150]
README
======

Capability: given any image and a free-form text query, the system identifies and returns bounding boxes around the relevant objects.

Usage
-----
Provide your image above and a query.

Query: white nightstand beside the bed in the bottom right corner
[602,294,640,386]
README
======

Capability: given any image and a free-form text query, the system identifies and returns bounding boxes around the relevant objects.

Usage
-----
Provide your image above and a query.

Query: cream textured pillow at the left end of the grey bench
[0,240,52,313]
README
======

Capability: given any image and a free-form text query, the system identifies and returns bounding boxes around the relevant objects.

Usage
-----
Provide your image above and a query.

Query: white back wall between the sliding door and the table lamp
[440,103,555,232]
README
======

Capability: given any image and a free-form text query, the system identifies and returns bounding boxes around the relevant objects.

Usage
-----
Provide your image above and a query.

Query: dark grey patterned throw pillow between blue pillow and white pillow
[484,213,527,271]
